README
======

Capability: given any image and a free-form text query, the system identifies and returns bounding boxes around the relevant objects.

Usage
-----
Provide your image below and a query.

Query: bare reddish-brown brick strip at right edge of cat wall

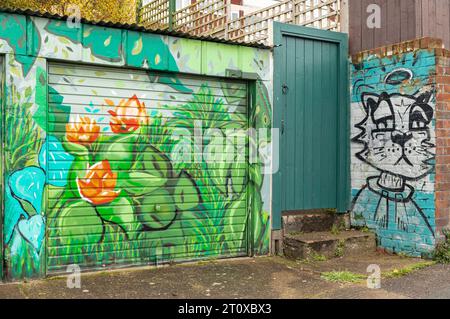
[435,50,450,237]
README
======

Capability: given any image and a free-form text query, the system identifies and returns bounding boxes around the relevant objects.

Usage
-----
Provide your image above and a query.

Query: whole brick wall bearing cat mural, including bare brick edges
[351,38,450,256]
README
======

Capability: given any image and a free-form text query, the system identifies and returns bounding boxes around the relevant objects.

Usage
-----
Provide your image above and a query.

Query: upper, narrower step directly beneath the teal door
[283,211,347,233]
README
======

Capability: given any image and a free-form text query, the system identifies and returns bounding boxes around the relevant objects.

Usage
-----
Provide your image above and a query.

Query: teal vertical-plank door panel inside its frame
[280,36,338,211]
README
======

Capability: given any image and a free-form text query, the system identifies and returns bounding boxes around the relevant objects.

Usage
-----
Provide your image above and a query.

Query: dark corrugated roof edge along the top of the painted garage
[0,7,271,49]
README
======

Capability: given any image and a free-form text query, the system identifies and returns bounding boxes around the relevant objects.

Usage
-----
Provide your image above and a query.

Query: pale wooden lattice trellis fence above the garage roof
[140,0,342,44]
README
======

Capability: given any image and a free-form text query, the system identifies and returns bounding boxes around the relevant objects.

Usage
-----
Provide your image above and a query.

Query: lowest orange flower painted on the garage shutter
[77,160,120,205]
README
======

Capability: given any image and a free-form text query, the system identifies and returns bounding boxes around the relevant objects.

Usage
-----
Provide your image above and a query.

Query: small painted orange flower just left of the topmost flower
[66,117,100,146]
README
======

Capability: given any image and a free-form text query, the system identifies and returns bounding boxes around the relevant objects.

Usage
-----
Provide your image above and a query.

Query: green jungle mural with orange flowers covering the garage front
[0,13,272,279]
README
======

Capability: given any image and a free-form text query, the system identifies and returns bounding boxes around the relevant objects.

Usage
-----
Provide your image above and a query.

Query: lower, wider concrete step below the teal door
[283,230,376,259]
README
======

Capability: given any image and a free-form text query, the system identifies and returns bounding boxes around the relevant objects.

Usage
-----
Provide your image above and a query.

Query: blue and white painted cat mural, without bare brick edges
[352,51,435,256]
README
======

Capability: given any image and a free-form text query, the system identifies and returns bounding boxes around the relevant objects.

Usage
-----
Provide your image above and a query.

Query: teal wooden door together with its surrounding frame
[274,24,349,229]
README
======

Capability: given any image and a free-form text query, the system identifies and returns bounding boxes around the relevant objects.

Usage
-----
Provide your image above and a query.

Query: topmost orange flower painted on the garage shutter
[107,95,147,134]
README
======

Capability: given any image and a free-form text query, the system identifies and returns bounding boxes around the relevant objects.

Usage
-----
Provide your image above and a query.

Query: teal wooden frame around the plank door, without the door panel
[272,22,351,230]
